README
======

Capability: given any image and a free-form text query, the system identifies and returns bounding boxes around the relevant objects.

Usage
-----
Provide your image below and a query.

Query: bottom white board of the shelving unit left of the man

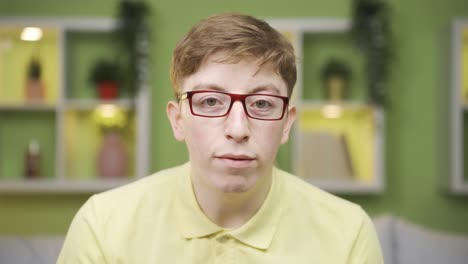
[0,179,132,194]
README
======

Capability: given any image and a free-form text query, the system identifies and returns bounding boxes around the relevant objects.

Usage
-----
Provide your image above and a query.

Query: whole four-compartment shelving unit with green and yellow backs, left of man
[0,17,151,193]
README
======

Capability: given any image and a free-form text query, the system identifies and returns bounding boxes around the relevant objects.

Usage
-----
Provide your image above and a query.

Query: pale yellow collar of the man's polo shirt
[175,163,284,250]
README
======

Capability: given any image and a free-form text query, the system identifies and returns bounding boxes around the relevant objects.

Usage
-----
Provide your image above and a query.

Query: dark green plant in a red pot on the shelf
[90,59,121,100]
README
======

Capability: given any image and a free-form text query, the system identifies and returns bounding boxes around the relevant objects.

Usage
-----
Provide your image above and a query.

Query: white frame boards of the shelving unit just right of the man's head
[266,18,385,194]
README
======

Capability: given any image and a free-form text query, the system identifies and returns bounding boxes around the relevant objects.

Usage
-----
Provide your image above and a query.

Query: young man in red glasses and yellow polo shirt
[58,14,383,264]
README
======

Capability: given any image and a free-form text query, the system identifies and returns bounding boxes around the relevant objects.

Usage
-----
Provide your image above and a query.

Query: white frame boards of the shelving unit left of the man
[0,17,150,193]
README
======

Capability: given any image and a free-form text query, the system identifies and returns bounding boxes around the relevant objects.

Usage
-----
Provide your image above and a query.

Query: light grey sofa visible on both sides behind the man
[0,215,468,264]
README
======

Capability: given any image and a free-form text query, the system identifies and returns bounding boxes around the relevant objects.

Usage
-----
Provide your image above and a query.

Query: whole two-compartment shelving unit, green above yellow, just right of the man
[270,18,385,194]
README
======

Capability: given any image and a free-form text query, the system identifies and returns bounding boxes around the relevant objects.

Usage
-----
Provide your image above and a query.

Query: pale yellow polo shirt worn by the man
[58,163,383,264]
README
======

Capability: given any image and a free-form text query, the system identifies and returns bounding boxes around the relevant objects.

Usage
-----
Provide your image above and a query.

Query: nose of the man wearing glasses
[224,101,250,143]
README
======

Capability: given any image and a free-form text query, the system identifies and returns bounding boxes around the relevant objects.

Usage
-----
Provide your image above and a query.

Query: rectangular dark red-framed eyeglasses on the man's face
[178,91,289,121]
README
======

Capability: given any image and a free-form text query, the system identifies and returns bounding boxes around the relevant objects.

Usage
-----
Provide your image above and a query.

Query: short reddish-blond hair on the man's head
[170,13,297,96]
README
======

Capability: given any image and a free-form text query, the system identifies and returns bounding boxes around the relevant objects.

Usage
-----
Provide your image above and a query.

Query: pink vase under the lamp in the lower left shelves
[97,132,128,178]
